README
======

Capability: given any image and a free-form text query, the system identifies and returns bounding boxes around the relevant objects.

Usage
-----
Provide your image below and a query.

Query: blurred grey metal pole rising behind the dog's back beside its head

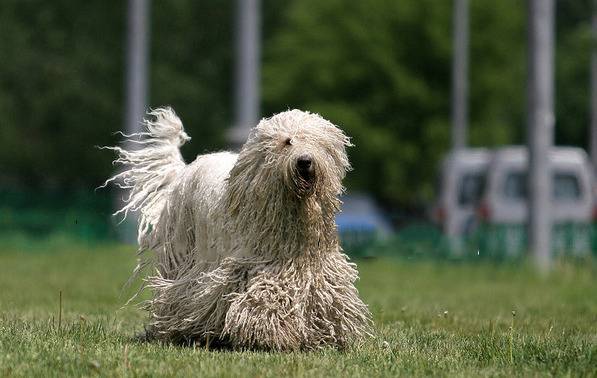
[229,0,261,148]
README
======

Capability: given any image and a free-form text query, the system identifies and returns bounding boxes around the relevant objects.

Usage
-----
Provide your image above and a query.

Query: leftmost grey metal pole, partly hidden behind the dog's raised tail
[117,0,150,243]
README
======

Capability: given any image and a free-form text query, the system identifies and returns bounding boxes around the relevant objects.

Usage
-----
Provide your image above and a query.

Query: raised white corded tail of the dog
[102,107,191,244]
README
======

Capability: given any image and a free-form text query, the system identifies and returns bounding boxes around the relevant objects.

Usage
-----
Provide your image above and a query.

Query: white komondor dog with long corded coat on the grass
[106,108,371,350]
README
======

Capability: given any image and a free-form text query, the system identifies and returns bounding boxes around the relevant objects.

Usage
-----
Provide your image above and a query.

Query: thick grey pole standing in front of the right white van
[527,0,554,272]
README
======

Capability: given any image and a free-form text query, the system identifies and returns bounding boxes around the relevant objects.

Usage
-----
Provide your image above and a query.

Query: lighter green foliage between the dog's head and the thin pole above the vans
[264,0,450,208]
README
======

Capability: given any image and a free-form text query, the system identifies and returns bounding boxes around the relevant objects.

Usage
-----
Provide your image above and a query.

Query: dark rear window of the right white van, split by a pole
[503,171,582,202]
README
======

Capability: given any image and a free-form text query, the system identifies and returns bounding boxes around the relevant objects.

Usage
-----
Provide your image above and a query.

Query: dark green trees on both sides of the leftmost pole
[0,0,234,189]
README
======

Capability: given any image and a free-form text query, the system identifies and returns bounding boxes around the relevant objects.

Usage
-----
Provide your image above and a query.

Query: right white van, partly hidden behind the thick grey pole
[478,146,593,256]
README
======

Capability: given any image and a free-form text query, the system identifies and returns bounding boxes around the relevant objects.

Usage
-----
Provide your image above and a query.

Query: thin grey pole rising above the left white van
[452,0,469,150]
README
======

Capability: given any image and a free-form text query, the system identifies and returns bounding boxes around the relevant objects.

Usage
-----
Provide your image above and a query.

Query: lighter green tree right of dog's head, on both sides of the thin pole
[264,0,525,210]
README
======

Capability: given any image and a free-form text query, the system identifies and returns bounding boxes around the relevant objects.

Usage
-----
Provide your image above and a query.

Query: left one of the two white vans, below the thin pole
[431,148,491,237]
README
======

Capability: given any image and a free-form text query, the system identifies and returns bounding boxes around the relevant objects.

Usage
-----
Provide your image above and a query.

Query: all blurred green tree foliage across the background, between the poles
[0,0,591,207]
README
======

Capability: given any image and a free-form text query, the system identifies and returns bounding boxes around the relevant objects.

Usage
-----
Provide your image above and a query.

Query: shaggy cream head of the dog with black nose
[231,110,351,204]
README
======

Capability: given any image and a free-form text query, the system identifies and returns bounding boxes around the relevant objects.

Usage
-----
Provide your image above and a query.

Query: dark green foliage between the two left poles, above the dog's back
[150,0,234,161]
